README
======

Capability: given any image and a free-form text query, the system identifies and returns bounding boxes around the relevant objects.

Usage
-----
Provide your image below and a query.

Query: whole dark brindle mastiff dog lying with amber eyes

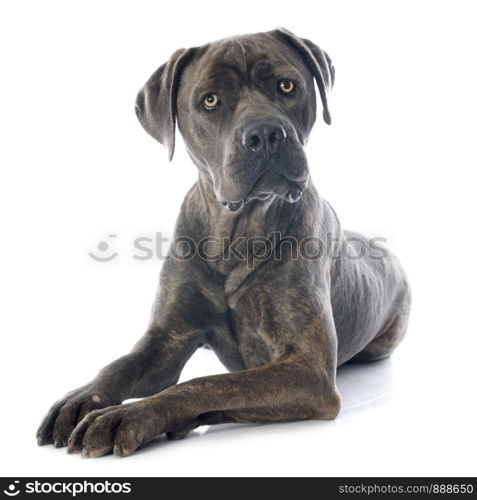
[37,29,410,457]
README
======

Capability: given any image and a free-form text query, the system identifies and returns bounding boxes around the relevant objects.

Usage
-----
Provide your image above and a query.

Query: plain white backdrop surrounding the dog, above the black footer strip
[0,0,477,476]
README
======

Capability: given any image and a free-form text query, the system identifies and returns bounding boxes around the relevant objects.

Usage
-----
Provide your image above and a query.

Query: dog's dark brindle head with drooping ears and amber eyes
[136,29,334,211]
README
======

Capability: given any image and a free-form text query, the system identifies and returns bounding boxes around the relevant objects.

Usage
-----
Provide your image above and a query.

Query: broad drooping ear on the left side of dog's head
[136,49,194,161]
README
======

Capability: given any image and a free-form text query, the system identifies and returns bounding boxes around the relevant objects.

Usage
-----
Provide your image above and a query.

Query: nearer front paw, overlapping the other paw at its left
[68,403,159,458]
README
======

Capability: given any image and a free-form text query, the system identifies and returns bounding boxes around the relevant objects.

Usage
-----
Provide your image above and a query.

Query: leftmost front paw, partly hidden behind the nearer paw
[36,386,117,448]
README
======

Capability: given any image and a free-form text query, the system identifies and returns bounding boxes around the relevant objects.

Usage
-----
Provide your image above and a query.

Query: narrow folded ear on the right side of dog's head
[275,28,335,125]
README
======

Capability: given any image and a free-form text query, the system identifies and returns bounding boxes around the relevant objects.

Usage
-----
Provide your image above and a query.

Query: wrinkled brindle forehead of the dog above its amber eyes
[182,33,311,91]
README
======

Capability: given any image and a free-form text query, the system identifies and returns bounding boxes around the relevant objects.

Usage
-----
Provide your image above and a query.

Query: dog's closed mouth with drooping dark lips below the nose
[222,170,308,212]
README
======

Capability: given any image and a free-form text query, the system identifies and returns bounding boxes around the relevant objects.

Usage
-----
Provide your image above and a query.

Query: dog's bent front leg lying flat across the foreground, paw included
[69,312,340,457]
